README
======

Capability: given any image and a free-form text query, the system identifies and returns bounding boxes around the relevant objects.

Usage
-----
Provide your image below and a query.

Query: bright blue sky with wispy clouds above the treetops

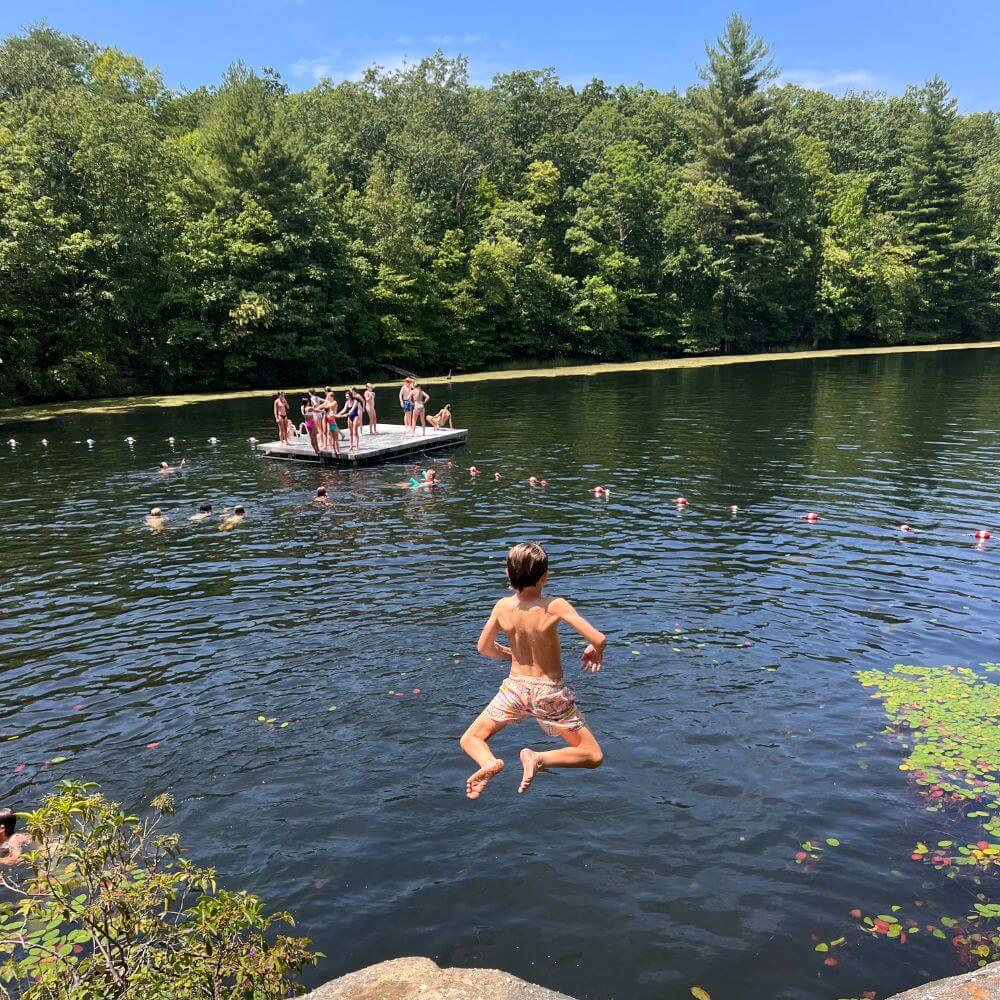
[0,0,1000,111]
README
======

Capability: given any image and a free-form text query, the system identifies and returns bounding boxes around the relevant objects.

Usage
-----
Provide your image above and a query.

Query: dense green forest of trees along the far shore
[0,16,1000,402]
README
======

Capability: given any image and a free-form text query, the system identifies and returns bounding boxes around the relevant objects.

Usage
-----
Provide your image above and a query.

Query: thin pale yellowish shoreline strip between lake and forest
[0,340,1000,424]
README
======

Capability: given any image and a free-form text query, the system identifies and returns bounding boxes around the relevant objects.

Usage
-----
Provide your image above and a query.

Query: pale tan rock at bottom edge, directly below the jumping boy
[306,958,573,1000]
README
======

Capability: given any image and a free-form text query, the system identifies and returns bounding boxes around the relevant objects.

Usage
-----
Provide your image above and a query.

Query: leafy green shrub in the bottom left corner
[0,782,319,1000]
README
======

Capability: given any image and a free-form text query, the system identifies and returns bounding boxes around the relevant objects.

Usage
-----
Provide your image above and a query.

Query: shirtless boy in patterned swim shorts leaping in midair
[461,542,607,799]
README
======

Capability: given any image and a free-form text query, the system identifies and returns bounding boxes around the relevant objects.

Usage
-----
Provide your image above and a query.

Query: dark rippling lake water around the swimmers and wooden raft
[0,350,1000,1000]
